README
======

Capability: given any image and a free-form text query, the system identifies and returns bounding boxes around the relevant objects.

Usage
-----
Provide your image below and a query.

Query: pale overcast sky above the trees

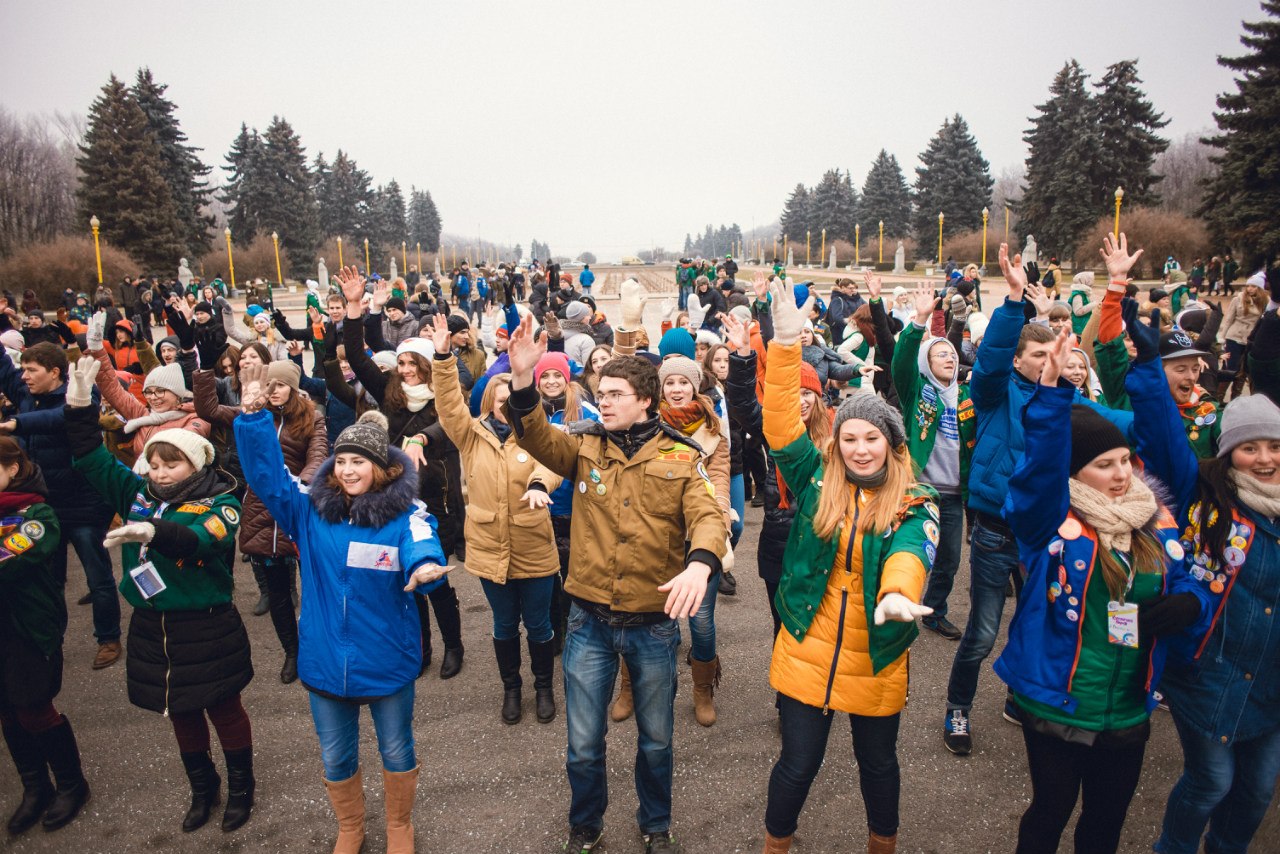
[0,0,1262,260]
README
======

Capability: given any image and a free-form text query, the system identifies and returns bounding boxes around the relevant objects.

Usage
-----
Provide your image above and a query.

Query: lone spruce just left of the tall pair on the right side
[913,113,995,242]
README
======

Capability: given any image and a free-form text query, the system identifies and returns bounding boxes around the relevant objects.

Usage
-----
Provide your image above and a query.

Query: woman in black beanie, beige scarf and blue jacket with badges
[996,316,1204,854]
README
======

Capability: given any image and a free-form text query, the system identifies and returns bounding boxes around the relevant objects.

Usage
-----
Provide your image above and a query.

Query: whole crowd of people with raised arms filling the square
[0,240,1280,854]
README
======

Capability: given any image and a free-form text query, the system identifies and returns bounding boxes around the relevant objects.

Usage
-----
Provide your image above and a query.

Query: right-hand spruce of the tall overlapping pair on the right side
[1092,59,1169,208]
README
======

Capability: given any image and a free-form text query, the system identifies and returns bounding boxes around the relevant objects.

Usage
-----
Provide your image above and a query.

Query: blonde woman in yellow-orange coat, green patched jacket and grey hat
[763,280,938,854]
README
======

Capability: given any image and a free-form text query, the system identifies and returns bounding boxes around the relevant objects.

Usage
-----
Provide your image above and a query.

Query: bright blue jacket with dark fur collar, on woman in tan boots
[236,410,444,699]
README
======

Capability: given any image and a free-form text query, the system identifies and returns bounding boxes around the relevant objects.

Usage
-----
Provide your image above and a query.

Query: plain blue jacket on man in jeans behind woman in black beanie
[969,298,1133,516]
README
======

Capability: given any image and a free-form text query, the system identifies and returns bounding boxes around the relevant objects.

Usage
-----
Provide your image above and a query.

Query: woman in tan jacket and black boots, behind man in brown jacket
[431,315,561,723]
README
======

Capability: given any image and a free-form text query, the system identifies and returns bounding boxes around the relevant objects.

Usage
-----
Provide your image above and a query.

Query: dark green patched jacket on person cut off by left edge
[0,502,67,656]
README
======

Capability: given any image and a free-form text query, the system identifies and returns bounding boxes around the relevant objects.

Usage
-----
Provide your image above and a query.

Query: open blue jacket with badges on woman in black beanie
[988,368,1208,714]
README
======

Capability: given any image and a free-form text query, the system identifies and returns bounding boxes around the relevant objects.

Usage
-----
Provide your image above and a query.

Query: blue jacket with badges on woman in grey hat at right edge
[1125,362,1280,745]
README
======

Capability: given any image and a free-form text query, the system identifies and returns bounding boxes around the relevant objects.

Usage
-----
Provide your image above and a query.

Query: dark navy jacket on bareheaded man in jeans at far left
[0,352,114,528]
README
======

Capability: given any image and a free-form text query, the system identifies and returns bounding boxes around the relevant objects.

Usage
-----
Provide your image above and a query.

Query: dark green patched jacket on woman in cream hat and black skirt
[73,446,241,611]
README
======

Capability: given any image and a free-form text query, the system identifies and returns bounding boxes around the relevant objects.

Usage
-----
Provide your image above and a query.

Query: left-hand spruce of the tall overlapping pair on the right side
[1015,59,1102,259]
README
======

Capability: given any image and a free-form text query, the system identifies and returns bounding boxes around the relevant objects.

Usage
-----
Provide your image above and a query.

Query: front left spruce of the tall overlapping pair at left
[76,74,186,270]
